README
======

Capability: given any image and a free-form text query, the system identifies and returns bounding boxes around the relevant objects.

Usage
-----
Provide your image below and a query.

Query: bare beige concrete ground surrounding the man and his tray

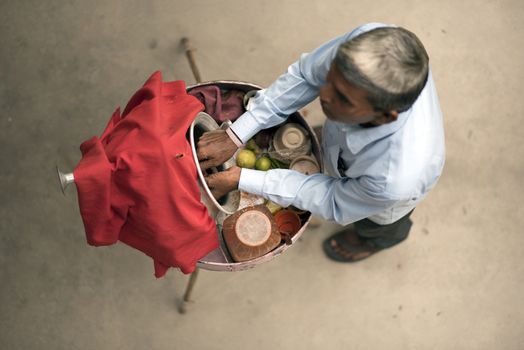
[0,0,524,350]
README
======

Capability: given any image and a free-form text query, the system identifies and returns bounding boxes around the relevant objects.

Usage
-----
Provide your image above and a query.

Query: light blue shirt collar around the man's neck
[335,109,411,154]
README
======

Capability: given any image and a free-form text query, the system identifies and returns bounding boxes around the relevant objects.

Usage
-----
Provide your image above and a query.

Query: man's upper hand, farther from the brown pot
[197,130,237,170]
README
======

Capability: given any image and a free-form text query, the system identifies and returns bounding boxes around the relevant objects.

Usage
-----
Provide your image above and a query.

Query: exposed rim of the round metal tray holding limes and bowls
[187,80,323,271]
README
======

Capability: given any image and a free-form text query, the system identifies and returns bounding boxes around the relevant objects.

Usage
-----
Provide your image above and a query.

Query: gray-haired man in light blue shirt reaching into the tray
[198,23,445,262]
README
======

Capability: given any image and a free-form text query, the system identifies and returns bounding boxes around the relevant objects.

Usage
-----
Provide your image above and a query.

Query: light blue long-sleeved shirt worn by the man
[231,23,445,225]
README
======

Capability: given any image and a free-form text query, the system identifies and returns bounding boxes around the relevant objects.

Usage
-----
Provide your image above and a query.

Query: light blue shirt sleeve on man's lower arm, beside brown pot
[239,169,401,225]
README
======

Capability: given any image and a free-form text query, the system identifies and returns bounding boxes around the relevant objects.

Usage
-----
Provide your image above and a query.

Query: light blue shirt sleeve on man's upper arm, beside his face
[231,23,384,143]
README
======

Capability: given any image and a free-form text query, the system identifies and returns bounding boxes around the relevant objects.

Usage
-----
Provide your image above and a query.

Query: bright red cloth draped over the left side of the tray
[74,72,218,277]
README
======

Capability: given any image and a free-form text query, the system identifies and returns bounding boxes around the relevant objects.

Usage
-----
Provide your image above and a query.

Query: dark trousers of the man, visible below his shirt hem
[353,209,414,249]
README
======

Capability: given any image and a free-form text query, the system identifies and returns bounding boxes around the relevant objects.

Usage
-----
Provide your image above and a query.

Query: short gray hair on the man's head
[335,27,429,112]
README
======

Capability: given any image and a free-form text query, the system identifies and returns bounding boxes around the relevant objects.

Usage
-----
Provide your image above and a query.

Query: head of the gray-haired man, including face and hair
[320,27,429,125]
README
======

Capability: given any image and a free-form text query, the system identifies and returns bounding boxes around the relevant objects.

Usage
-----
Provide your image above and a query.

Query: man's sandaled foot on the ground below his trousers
[322,228,379,262]
